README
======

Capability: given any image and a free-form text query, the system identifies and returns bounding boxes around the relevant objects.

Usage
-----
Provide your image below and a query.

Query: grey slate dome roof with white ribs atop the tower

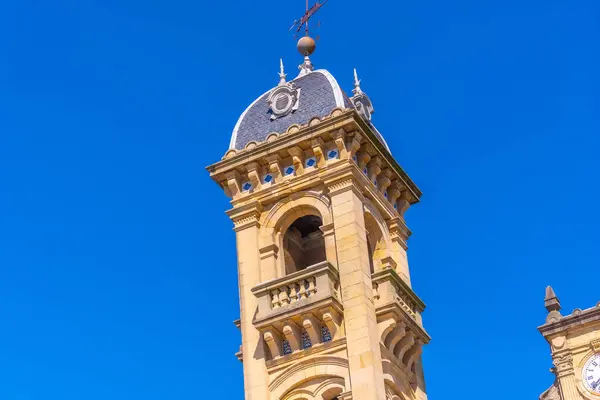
[229,69,389,150]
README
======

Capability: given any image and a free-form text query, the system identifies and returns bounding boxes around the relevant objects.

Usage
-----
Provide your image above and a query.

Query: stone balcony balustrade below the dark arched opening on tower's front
[252,261,339,325]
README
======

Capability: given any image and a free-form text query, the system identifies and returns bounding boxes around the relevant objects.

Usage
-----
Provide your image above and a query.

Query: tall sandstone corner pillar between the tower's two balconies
[327,175,385,400]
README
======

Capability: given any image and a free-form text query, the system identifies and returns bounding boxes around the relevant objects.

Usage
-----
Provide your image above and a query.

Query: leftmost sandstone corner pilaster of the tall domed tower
[228,207,269,400]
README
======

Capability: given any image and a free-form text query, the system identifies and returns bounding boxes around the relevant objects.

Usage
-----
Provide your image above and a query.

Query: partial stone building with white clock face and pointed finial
[538,286,600,400]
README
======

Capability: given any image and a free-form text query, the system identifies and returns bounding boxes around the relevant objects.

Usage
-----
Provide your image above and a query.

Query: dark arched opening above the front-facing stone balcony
[283,215,325,275]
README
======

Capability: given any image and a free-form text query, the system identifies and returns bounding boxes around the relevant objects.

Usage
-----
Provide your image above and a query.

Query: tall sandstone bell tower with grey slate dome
[208,51,429,400]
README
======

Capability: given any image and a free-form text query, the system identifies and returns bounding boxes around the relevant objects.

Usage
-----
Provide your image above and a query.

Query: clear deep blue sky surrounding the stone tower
[0,0,600,400]
